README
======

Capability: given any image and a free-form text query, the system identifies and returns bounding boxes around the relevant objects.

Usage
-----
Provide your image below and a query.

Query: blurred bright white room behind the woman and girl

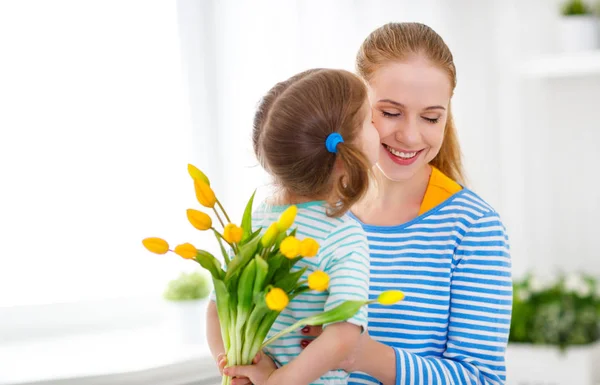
[0,0,600,385]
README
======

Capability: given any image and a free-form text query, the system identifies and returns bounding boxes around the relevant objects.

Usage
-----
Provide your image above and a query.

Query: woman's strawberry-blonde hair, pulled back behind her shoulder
[356,23,464,183]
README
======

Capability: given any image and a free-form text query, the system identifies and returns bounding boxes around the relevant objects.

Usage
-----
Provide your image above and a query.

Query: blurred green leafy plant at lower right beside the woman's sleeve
[509,274,600,349]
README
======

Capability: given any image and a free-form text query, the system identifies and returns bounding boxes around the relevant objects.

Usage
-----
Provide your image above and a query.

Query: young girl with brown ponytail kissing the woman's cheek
[207,69,379,385]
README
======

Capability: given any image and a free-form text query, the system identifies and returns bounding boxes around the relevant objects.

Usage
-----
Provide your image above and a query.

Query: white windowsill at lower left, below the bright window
[0,296,220,385]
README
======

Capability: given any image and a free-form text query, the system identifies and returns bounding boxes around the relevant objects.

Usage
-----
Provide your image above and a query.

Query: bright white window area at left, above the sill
[0,0,195,307]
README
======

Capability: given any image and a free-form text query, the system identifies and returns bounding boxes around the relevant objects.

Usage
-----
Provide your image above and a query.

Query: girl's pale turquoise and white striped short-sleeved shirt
[252,201,369,385]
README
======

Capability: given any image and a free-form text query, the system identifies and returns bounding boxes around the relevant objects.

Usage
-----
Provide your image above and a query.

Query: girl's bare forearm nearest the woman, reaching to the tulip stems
[224,322,361,385]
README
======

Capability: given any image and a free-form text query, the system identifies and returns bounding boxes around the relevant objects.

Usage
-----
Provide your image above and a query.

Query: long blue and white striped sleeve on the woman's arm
[394,211,512,385]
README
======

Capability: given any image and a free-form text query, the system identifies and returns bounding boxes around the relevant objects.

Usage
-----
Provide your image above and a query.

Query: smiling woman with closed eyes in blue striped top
[233,23,512,385]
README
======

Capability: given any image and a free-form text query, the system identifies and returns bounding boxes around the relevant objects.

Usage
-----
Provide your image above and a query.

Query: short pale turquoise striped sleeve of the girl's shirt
[320,221,369,330]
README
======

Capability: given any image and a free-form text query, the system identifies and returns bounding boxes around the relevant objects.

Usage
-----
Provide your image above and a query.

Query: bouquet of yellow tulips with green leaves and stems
[143,165,404,384]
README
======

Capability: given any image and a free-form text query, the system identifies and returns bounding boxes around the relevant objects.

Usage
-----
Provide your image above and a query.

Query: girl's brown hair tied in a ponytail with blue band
[252,69,371,216]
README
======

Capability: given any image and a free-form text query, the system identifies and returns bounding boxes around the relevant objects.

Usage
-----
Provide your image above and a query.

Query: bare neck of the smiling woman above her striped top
[352,165,431,226]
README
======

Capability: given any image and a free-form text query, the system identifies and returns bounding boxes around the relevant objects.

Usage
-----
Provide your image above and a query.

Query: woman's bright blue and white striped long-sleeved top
[349,189,512,385]
